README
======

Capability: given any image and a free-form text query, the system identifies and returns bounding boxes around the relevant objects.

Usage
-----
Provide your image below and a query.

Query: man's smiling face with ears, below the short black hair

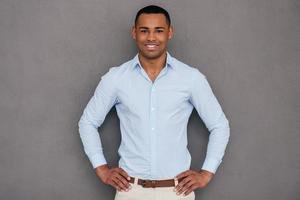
[132,13,173,59]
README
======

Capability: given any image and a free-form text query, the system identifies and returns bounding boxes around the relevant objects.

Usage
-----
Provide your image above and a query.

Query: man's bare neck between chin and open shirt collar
[138,52,167,73]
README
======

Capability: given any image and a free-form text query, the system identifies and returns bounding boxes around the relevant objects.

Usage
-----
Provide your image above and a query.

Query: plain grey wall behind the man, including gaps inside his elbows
[0,0,300,200]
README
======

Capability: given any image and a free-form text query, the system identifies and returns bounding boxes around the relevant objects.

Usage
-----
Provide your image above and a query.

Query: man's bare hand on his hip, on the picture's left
[96,164,131,192]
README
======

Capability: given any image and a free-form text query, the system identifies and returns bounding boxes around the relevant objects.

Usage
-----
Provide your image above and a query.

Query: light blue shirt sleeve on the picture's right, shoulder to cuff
[190,69,230,173]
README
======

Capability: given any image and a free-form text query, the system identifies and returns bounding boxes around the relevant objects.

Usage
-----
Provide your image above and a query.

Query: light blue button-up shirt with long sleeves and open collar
[78,53,230,179]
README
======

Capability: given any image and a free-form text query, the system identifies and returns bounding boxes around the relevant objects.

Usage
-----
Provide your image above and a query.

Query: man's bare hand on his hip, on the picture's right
[175,170,214,195]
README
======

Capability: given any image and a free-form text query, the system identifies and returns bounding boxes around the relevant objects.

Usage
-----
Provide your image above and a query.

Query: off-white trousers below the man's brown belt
[115,178,195,200]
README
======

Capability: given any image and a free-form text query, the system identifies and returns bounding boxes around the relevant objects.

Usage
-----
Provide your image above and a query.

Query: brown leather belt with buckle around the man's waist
[129,177,180,188]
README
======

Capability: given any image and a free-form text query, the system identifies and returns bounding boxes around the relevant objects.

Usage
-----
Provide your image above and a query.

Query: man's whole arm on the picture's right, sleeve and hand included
[176,70,230,195]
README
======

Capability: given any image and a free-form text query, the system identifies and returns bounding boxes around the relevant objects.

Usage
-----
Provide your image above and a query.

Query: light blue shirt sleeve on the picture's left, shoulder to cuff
[78,67,117,168]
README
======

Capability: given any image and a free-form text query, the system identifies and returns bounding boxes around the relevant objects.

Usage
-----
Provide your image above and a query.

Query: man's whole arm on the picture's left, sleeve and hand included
[78,68,129,191]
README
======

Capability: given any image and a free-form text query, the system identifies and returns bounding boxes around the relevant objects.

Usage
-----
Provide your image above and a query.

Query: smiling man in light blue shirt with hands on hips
[79,5,229,200]
